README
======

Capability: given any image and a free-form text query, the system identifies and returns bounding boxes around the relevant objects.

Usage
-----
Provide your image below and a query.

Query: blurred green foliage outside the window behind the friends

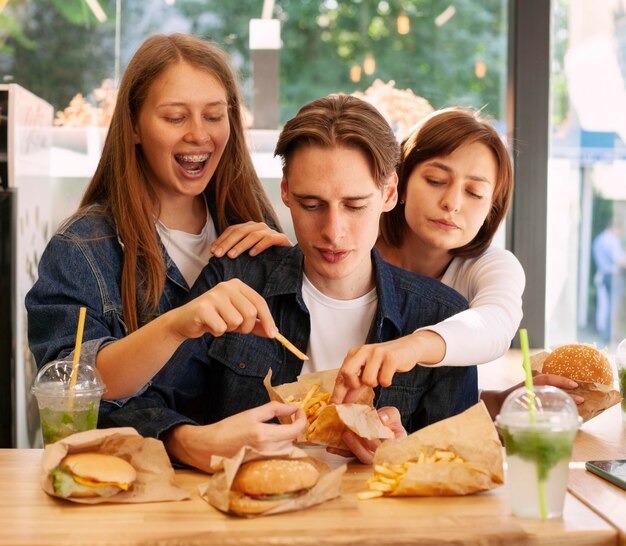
[0,0,507,121]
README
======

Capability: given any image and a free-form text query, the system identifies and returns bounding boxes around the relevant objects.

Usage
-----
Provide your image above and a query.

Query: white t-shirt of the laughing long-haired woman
[156,210,217,286]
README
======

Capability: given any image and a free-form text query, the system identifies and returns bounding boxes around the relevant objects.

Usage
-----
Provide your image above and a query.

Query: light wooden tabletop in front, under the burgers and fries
[0,449,618,546]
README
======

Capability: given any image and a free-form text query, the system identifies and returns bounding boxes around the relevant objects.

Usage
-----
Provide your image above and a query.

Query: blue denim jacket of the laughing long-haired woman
[25,199,238,413]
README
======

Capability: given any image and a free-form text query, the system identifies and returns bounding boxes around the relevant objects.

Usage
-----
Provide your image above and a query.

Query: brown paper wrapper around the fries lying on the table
[374,401,504,496]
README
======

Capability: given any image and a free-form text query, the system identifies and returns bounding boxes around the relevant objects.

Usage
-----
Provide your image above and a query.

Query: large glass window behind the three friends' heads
[0,0,508,238]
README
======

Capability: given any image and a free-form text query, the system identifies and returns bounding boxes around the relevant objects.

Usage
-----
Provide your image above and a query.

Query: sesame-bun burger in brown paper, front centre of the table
[199,447,346,516]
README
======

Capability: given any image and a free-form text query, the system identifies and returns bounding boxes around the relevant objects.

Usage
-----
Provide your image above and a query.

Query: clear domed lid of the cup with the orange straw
[31,360,106,396]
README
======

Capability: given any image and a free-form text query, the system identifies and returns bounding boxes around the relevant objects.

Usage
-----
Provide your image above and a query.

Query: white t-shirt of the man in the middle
[302,276,378,373]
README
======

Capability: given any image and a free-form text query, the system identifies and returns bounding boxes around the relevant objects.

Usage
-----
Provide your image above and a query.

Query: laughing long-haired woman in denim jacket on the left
[26,34,290,411]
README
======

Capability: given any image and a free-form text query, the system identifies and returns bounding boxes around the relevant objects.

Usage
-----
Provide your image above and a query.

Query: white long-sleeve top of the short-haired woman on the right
[421,246,526,366]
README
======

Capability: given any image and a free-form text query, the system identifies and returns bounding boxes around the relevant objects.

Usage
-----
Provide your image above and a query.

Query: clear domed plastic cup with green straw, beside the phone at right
[496,386,582,519]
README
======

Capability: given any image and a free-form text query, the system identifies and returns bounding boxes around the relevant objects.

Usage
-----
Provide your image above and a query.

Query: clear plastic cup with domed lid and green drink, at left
[31,360,105,445]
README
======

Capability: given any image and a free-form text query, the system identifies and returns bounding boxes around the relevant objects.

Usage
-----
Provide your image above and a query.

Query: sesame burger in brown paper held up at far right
[531,344,621,421]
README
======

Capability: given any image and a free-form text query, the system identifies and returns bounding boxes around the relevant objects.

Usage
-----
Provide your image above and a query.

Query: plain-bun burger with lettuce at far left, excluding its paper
[50,453,137,498]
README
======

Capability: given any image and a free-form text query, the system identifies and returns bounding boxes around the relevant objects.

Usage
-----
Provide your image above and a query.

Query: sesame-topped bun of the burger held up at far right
[542,344,614,387]
